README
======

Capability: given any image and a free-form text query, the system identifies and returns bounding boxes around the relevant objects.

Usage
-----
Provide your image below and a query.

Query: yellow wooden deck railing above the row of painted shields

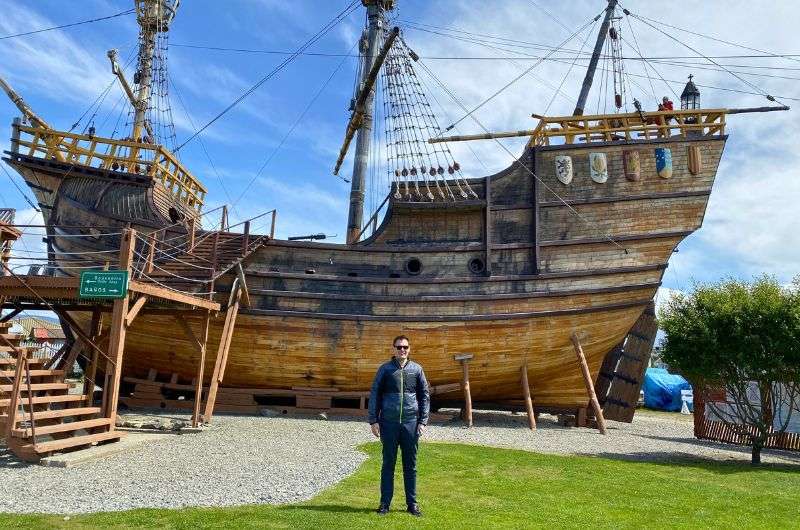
[531,109,726,146]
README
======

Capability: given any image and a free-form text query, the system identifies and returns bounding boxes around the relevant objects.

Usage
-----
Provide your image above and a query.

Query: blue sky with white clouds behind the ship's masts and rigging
[0,0,800,310]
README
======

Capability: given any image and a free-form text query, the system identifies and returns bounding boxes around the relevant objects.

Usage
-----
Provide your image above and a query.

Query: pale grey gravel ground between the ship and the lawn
[0,413,800,513]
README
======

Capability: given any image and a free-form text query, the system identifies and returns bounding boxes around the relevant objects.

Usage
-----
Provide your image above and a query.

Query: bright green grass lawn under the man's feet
[0,443,800,530]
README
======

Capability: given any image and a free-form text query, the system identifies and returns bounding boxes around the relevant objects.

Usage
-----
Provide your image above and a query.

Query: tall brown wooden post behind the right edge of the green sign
[103,228,136,424]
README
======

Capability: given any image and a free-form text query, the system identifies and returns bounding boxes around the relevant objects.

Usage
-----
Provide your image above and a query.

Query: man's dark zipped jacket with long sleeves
[369,358,431,425]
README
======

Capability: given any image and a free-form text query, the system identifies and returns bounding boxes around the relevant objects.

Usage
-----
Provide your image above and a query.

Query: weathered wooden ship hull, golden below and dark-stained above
[7,131,726,408]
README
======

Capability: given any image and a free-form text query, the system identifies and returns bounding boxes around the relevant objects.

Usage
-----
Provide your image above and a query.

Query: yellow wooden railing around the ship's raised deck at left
[11,123,206,211]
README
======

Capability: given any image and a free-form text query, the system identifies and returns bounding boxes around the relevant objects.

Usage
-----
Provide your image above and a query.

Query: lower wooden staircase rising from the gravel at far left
[0,323,122,462]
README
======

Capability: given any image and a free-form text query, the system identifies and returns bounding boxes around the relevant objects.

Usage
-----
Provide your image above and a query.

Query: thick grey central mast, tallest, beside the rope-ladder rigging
[347,0,394,244]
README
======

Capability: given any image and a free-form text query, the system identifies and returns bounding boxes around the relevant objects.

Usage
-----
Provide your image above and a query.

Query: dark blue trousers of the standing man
[381,420,419,506]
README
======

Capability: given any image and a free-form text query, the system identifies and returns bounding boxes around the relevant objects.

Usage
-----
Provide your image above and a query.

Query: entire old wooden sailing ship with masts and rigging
[0,0,788,421]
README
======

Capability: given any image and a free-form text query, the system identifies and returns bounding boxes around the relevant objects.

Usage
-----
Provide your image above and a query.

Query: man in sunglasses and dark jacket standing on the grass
[369,335,430,517]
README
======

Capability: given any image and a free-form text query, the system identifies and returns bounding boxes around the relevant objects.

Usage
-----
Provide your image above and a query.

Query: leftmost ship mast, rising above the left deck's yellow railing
[131,0,180,141]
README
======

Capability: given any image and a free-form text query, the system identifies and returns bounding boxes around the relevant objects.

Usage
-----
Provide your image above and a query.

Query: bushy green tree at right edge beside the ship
[659,276,800,464]
